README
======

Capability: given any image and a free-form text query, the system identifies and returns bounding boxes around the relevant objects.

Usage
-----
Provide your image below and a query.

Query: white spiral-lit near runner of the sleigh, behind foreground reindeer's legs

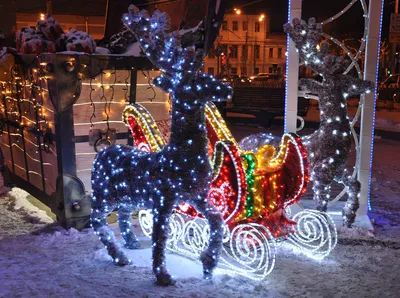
[139,210,276,280]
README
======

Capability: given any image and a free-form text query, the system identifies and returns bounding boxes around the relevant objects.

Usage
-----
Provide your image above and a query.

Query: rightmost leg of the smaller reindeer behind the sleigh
[339,176,361,228]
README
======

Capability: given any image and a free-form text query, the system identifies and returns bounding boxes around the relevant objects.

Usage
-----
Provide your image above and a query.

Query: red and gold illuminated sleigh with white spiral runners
[123,103,336,279]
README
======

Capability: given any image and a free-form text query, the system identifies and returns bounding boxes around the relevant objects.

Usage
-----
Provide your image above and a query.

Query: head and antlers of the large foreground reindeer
[122,5,232,106]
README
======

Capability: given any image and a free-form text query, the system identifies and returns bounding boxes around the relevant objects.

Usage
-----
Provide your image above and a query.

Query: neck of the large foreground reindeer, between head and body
[169,100,208,154]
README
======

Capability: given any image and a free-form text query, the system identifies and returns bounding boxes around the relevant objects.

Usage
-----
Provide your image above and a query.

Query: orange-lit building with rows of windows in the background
[205,12,286,76]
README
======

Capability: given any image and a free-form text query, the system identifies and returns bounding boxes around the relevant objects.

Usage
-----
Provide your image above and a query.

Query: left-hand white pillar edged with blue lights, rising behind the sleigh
[284,0,302,133]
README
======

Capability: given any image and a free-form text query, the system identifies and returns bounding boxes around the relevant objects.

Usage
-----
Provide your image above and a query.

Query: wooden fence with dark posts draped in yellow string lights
[0,54,168,229]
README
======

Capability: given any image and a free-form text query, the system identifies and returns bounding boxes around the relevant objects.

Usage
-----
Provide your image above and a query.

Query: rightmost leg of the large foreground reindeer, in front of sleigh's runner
[194,193,224,279]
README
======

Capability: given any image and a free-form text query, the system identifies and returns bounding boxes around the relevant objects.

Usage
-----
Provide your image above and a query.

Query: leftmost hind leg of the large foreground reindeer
[90,194,131,266]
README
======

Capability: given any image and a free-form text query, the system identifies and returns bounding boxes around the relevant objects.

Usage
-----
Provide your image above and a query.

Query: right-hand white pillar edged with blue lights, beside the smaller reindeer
[357,0,384,216]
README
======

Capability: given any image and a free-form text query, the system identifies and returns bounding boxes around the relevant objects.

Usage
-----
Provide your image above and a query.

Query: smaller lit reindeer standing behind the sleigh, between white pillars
[284,18,373,227]
